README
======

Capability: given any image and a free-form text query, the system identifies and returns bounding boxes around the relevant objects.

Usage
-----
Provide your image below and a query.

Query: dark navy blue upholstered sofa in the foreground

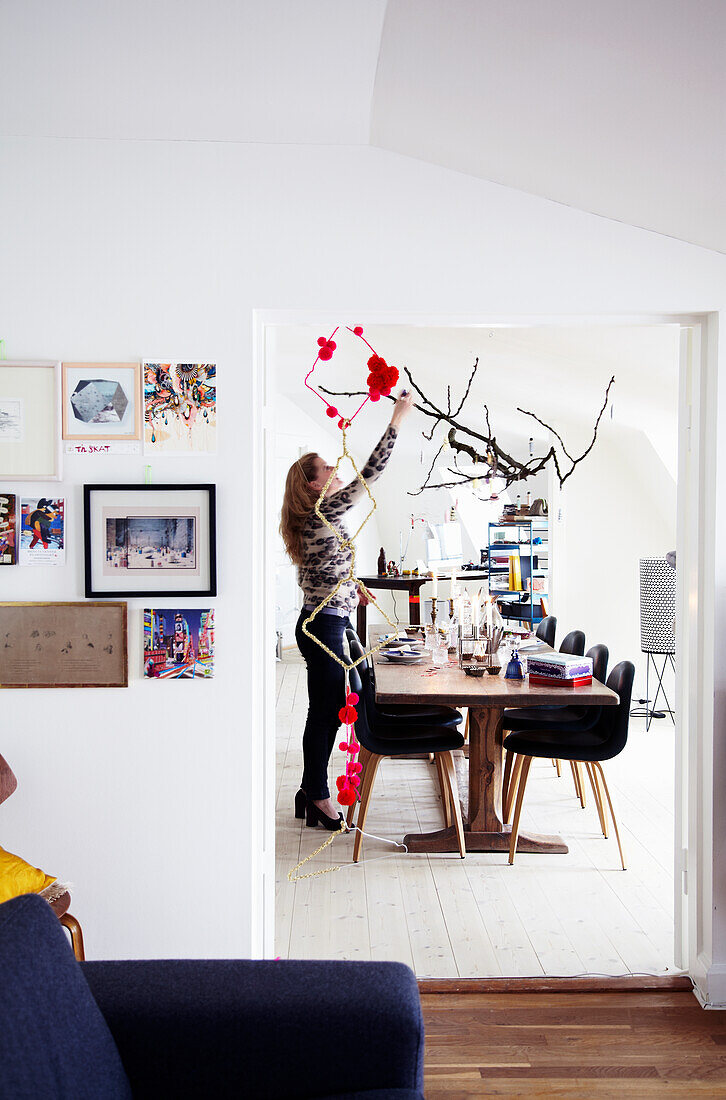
[0,894,424,1100]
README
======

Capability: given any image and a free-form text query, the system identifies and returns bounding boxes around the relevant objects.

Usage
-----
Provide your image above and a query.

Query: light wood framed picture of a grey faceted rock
[61,363,142,442]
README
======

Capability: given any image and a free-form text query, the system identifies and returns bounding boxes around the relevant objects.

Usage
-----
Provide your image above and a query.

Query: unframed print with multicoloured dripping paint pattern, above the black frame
[144,361,217,454]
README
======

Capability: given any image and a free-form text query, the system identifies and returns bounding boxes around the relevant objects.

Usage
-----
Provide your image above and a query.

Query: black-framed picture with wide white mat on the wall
[84,485,217,596]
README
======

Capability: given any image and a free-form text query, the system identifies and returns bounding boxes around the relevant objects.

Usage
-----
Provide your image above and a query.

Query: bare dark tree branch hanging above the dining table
[320,356,615,496]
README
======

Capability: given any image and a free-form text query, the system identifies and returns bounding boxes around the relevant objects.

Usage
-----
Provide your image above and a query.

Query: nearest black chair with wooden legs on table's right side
[504,661,635,870]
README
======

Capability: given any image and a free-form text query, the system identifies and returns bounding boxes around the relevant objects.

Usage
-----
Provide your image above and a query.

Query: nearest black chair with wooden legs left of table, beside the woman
[347,662,466,864]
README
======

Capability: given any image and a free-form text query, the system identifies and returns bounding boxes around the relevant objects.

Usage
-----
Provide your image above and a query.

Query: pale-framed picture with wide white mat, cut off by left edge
[0,359,63,481]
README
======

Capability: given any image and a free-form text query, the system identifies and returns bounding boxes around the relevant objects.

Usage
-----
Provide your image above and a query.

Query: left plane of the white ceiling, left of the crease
[0,0,385,144]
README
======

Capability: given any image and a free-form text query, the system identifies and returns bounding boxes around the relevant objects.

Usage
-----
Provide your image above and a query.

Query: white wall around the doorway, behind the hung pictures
[0,139,726,961]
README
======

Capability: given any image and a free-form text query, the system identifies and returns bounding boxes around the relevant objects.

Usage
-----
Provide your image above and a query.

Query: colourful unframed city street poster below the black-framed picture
[144,607,215,680]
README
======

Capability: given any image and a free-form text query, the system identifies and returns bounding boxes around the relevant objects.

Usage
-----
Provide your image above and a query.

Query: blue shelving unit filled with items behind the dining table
[487,516,550,628]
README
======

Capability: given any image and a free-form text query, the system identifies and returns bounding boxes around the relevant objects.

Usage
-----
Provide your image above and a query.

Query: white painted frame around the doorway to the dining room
[250,310,726,1003]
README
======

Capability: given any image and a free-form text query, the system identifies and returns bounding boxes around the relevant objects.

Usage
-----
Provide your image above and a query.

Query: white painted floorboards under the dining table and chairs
[275,655,674,978]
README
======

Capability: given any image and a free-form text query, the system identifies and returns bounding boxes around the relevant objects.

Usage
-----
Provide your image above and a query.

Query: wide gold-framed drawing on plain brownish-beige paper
[0,603,129,688]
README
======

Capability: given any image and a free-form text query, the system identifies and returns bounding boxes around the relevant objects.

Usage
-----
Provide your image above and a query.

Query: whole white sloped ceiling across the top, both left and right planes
[0,0,726,252]
